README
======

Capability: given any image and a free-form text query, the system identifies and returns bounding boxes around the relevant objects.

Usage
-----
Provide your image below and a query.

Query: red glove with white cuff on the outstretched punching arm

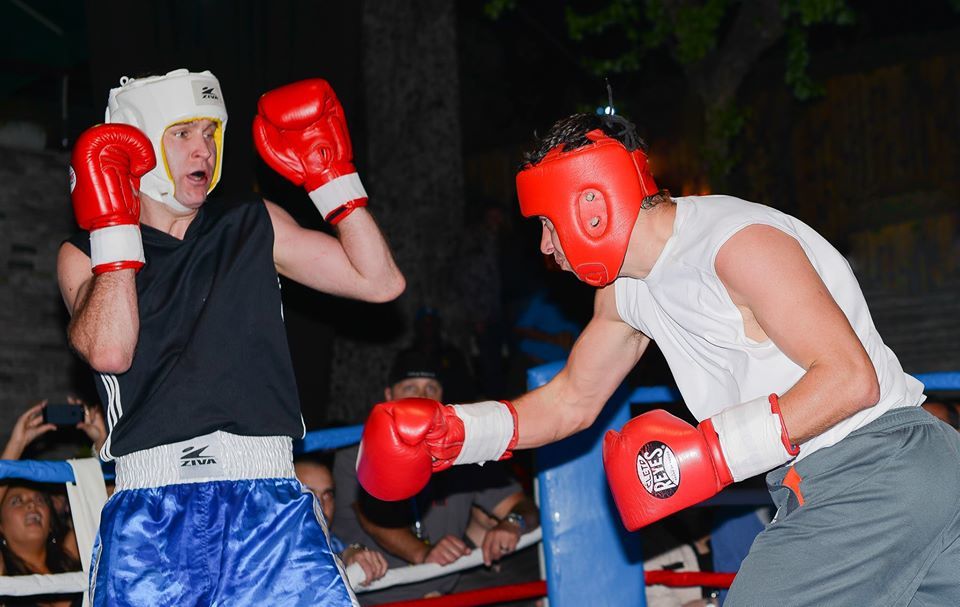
[357,398,518,501]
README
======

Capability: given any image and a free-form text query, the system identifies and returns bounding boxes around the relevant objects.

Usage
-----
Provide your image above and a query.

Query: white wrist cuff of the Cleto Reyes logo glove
[711,396,793,481]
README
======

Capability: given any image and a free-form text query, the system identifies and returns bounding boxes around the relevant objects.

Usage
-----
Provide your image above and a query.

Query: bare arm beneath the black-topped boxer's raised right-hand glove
[265,201,406,302]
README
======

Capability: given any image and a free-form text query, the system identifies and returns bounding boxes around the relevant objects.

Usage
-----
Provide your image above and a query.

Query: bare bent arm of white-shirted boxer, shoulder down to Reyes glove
[716,225,880,443]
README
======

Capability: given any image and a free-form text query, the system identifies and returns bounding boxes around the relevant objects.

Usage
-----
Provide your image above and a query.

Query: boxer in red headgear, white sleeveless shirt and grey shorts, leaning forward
[358,115,960,606]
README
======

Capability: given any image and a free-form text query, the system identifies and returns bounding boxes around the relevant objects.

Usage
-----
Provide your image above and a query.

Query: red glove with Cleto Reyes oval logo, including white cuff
[603,394,799,531]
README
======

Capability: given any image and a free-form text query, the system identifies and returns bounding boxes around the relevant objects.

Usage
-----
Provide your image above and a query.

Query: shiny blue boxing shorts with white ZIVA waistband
[90,431,358,607]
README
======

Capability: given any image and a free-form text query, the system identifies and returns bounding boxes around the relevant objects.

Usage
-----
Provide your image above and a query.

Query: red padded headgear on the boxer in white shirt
[517,129,658,287]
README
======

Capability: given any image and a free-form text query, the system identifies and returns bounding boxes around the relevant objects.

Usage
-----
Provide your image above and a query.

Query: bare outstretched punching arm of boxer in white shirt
[513,285,650,449]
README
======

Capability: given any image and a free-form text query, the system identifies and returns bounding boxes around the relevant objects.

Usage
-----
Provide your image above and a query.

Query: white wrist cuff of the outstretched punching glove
[453,400,513,466]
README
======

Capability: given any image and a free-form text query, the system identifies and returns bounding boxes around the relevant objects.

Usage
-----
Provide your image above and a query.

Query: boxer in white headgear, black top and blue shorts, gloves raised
[57,69,404,606]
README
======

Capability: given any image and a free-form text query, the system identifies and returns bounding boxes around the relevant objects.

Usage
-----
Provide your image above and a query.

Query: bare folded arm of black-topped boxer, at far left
[57,243,140,373]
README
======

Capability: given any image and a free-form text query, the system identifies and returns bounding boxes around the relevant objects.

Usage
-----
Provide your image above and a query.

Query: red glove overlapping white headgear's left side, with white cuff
[70,124,157,274]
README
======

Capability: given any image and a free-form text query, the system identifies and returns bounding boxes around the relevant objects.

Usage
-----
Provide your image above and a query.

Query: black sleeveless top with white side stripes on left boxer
[69,199,304,459]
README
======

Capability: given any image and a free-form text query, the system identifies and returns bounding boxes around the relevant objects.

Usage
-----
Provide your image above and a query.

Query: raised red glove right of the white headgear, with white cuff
[253,78,367,224]
